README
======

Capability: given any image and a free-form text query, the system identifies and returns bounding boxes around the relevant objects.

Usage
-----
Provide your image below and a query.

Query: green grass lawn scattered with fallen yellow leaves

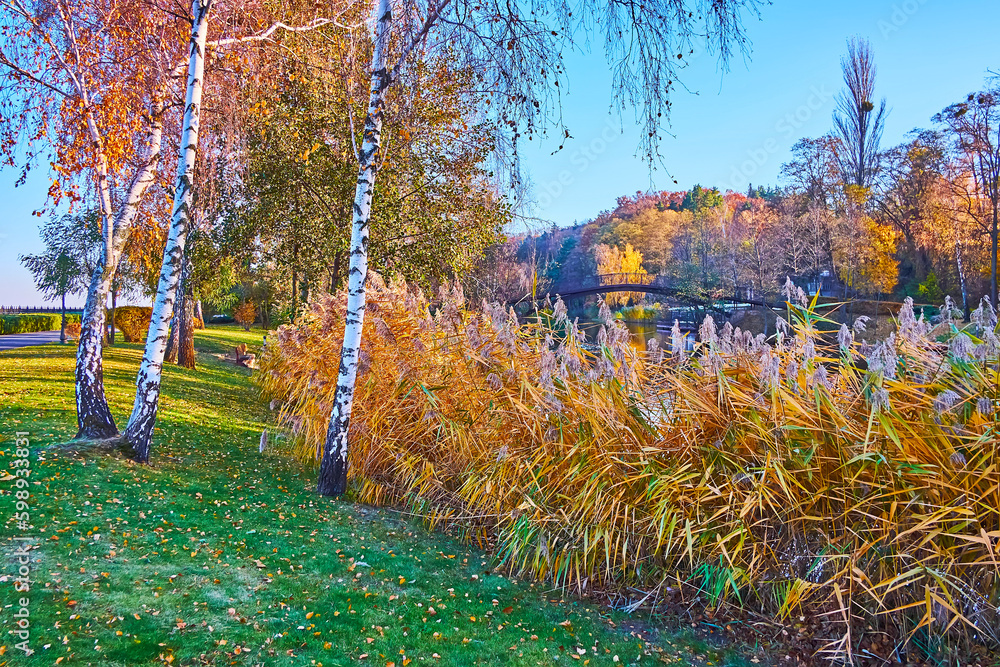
[0,327,735,667]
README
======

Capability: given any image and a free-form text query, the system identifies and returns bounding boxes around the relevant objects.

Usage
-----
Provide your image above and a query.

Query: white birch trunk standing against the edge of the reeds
[318,0,392,496]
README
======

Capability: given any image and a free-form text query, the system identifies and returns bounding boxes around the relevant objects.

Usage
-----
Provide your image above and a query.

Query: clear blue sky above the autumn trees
[0,0,1000,305]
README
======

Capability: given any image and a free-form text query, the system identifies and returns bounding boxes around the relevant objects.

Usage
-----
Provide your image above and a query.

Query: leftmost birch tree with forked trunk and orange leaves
[0,0,184,438]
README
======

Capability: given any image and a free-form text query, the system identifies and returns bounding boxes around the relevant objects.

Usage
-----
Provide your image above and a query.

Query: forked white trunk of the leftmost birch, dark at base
[76,91,165,440]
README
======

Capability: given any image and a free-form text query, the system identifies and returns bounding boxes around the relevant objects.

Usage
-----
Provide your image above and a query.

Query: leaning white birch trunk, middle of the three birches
[125,0,212,463]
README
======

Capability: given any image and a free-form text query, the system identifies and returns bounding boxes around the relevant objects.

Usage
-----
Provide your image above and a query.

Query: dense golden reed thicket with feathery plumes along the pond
[258,278,1000,658]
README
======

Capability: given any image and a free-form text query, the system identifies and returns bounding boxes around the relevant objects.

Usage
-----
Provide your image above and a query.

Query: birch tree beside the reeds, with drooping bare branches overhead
[318,0,758,496]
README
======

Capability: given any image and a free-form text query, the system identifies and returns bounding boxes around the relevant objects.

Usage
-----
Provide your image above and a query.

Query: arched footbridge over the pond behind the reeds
[519,273,773,313]
